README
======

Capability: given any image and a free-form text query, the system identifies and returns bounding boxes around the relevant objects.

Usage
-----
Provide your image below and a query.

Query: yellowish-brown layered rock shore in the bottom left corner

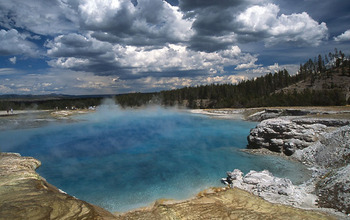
[0,153,115,220]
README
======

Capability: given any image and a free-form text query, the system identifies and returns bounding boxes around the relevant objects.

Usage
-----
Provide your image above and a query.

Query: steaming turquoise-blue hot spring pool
[0,106,312,211]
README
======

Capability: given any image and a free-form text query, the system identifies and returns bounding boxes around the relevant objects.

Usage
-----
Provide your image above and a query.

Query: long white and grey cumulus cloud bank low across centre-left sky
[46,31,257,78]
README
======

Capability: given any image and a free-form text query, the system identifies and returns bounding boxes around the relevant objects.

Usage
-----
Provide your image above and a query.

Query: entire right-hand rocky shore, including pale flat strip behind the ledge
[200,106,350,215]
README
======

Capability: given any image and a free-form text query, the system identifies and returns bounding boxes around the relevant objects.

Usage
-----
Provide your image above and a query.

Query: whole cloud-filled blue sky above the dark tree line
[0,0,350,95]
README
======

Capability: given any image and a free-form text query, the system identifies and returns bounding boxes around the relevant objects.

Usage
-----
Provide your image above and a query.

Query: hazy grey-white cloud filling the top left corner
[0,0,79,35]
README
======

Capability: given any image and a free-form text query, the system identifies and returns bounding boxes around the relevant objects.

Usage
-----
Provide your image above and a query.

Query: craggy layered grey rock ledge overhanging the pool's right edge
[247,117,350,156]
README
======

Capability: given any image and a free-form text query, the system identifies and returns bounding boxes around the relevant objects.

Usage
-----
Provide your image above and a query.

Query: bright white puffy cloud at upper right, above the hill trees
[236,3,328,46]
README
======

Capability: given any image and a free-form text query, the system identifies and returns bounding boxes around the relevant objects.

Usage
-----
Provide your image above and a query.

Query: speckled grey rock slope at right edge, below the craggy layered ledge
[293,126,350,214]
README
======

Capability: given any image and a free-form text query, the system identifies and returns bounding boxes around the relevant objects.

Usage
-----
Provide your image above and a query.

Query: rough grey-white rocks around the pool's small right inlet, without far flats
[246,117,350,215]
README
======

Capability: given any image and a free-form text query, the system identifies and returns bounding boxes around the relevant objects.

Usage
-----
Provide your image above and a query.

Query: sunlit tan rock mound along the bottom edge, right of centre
[118,188,336,220]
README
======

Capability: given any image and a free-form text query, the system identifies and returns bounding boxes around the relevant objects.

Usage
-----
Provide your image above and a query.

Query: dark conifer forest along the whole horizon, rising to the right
[0,49,350,110]
